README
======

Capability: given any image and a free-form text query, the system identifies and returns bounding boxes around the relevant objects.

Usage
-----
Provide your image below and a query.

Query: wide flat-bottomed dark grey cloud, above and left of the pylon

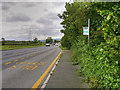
[6,14,31,22]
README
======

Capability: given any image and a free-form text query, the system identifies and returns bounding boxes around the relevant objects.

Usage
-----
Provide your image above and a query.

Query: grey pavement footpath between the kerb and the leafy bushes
[45,50,89,90]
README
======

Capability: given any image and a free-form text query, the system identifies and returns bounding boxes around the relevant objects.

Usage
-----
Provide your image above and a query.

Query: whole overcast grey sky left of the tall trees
[2,2,65,40]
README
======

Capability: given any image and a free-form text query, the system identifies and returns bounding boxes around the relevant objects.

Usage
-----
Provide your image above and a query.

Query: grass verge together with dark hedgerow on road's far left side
[0,38,45,51]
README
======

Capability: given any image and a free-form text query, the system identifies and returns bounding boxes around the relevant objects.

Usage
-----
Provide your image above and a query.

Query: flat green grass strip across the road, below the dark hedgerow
[0,45,44,51]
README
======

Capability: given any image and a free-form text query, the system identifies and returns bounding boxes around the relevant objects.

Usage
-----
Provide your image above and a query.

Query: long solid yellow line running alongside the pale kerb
[31,50,62,90]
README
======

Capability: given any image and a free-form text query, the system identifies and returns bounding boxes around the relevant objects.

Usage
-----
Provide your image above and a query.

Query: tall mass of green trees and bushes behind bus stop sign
[58,2,120,88]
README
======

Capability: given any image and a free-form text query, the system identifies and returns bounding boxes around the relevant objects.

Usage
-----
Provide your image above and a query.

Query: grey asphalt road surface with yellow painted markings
[2,46,61,88]
